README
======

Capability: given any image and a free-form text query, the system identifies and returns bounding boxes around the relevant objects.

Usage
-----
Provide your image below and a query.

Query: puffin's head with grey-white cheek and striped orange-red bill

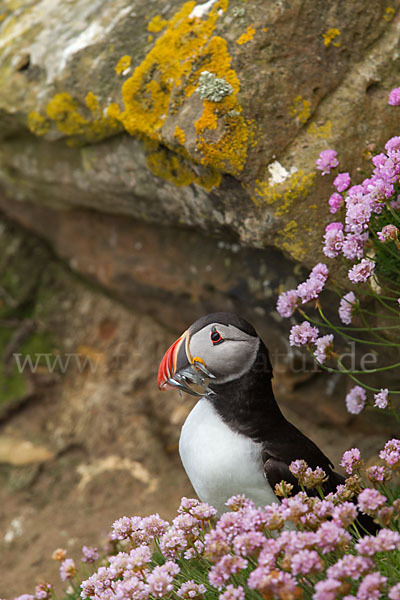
[158,312,272,396]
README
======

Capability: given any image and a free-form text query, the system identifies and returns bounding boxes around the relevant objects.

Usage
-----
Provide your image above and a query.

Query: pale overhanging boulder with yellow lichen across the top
[0,0,400,263]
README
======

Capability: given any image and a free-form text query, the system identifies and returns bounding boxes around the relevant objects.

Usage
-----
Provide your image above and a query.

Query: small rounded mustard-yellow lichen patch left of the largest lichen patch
[46,92,119,141]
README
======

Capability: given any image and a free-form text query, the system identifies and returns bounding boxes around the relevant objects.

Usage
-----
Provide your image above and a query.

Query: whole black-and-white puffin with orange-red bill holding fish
[158,312,372,521]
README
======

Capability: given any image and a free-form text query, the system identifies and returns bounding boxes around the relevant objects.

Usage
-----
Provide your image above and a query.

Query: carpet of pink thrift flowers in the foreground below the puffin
[9,439,400,600]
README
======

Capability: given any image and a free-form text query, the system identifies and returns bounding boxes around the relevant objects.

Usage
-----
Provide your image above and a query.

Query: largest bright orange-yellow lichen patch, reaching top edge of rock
[107,0,249,174]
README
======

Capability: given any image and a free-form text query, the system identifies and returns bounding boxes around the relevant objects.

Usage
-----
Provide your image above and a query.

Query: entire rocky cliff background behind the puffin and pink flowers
[0,0,400,597]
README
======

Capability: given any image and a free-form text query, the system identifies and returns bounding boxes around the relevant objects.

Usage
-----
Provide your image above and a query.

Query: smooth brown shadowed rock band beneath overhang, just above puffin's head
[0,198,302,340]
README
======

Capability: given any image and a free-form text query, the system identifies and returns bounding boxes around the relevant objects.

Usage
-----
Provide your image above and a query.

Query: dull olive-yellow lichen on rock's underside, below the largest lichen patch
[146,142,221,190]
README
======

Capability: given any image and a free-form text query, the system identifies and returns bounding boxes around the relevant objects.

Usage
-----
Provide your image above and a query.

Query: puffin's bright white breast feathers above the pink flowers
[179,398,278,512]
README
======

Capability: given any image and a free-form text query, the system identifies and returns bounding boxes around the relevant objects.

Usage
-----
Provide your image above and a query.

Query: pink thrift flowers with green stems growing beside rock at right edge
[276,88,400,421]
